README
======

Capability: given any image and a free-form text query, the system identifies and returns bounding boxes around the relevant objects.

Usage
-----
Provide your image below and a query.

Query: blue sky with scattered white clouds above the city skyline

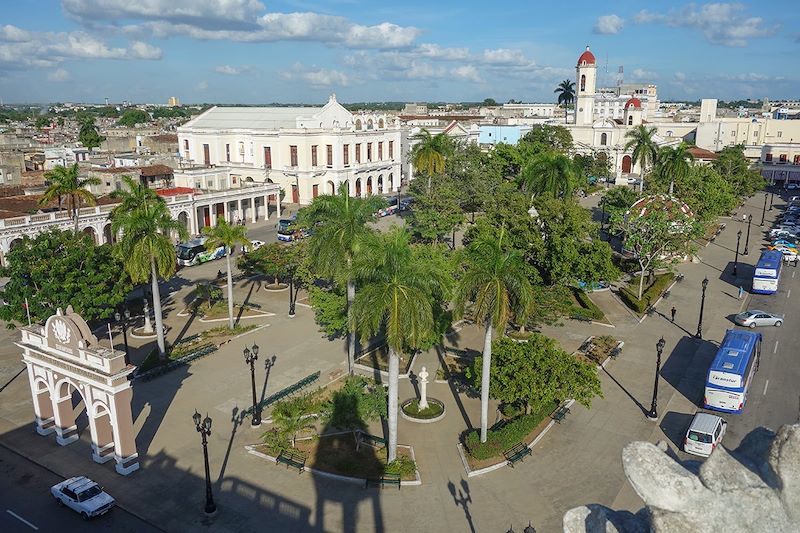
[0,0,800,104]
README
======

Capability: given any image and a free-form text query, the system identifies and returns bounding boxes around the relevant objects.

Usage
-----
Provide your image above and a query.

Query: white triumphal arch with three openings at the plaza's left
[16,306,139,475]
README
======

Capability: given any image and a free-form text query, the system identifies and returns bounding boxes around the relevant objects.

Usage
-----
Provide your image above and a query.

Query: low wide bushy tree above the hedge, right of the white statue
[467,333,603,409]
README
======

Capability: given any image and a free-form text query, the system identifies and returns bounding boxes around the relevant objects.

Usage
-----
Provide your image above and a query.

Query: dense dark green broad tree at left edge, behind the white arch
[0,230,132,323]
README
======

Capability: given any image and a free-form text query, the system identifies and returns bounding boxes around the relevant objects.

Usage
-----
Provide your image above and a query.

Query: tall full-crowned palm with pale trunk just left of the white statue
[350,227,444,462]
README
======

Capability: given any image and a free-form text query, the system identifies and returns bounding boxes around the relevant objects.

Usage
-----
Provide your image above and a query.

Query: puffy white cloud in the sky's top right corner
[633,3,777,46]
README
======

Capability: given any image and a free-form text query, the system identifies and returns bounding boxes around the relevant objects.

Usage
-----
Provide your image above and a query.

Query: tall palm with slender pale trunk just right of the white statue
[454,230,533,442]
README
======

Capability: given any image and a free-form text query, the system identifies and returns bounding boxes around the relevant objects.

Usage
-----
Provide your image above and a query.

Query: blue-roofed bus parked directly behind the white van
[703,329,761,413]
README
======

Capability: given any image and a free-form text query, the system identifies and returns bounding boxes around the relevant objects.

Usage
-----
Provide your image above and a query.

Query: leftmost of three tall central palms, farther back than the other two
[300,182,383,374]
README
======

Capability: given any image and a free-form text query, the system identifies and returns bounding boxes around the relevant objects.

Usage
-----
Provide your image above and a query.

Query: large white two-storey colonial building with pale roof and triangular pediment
[176,95,402,204]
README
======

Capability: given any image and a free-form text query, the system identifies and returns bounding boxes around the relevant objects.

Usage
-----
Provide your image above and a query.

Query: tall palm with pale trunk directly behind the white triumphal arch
[111,176,188,357]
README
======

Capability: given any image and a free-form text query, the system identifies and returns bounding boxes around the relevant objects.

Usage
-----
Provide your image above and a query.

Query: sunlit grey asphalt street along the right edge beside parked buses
[724,189,800,448]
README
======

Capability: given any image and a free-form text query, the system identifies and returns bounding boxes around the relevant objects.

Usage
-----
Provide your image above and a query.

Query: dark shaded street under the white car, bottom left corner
[0,446,160,533]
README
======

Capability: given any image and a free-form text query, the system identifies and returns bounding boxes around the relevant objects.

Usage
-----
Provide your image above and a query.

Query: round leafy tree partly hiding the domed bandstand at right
[612,195,699,300]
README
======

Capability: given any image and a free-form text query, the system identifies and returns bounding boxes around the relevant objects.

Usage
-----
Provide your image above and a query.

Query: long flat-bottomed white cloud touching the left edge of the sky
[0,25,161,68]
